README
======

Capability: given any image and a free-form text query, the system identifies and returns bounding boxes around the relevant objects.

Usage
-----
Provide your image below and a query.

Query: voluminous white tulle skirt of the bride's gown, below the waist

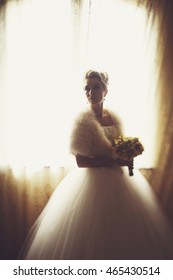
[22,168,173,260]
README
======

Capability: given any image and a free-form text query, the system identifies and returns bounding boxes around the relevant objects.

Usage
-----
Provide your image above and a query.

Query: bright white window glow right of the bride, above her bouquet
[82,1,155,166]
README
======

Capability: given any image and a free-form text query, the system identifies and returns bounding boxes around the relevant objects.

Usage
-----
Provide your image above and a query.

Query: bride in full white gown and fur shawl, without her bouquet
[22,71,173,260]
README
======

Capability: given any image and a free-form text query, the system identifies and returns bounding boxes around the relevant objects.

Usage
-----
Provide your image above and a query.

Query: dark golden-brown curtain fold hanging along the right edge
[149,1,173,220]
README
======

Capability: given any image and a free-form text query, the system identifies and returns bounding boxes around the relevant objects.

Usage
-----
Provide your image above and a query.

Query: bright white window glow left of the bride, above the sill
[6,1,78,171]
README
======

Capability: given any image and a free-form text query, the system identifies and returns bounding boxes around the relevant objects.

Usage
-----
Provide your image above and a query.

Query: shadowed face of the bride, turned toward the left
[85,78,107,106]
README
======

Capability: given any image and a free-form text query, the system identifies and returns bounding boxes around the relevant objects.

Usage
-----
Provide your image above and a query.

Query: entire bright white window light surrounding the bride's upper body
[3,0,157,173]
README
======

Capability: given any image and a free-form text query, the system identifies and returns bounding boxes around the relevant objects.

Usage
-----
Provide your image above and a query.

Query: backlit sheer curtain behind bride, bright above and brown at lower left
[0,0,169,258]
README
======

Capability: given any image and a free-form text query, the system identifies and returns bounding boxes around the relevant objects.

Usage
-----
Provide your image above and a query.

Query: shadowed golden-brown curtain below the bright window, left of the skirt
[0,167,67,259]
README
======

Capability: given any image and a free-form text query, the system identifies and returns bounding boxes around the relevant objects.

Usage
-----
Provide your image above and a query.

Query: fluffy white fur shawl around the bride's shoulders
[70,110,122,158]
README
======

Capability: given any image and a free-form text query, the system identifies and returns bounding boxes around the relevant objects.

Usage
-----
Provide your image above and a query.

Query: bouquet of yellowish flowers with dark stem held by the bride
[113,136,144,176]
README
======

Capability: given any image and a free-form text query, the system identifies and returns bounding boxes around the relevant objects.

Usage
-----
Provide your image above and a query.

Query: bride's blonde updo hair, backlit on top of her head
[84,70,109,91]
